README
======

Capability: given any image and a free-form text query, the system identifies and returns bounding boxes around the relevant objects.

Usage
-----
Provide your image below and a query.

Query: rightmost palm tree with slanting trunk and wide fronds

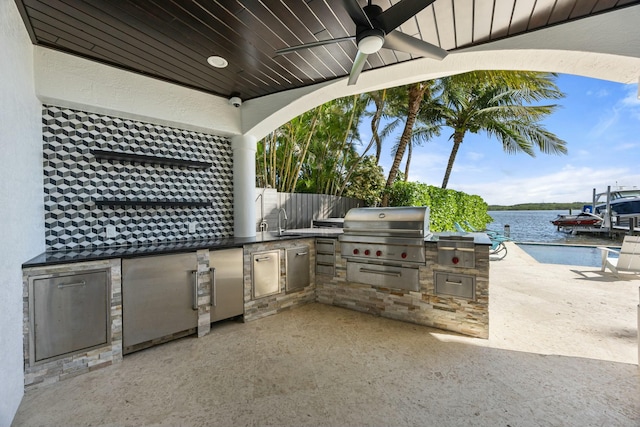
[438,71,567,188]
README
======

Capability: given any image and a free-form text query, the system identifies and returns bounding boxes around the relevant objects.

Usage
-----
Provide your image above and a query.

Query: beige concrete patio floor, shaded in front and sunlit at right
[13,244,640,427]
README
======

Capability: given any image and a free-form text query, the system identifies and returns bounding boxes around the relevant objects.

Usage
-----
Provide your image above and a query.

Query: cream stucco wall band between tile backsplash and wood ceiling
[34,46,242,136]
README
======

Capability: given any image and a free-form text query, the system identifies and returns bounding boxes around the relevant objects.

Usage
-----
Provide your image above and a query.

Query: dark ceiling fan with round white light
[276,0,448,85]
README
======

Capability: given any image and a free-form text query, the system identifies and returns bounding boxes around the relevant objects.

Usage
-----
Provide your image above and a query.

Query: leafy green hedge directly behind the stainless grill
[389,181,493,232]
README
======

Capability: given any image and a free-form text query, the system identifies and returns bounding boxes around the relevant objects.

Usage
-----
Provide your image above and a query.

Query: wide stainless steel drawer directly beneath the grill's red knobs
[347,262,420,292]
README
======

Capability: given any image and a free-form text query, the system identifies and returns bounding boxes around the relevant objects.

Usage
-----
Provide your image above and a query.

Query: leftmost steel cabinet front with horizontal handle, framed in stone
[29,270,111,363]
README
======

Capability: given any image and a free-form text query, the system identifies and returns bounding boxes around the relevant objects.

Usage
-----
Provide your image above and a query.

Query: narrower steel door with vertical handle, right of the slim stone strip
[209,248,244,322]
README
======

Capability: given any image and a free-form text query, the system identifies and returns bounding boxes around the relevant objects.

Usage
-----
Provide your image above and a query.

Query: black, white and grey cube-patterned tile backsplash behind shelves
[42,105,233,250]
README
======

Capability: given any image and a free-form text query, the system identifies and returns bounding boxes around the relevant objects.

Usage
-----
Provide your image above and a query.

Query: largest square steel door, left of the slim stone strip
[122,252,198,352]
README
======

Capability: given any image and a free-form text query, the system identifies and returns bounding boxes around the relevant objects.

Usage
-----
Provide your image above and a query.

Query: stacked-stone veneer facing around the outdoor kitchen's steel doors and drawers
[23,238,489,387]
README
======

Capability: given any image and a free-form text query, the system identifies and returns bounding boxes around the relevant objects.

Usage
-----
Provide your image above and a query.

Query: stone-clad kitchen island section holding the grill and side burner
[316,208,491,338]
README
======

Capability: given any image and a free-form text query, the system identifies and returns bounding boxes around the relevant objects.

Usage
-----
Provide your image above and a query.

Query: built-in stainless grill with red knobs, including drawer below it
[340,207,430,291]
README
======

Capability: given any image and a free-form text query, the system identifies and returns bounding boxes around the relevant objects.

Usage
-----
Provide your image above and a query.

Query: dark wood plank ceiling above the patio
[16,0,640,100]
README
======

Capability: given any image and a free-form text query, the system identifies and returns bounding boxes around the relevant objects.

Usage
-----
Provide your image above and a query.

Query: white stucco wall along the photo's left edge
[0,0,44,426]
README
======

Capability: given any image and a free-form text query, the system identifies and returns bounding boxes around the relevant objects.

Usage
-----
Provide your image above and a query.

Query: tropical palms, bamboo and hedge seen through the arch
[256,71,567,230]
